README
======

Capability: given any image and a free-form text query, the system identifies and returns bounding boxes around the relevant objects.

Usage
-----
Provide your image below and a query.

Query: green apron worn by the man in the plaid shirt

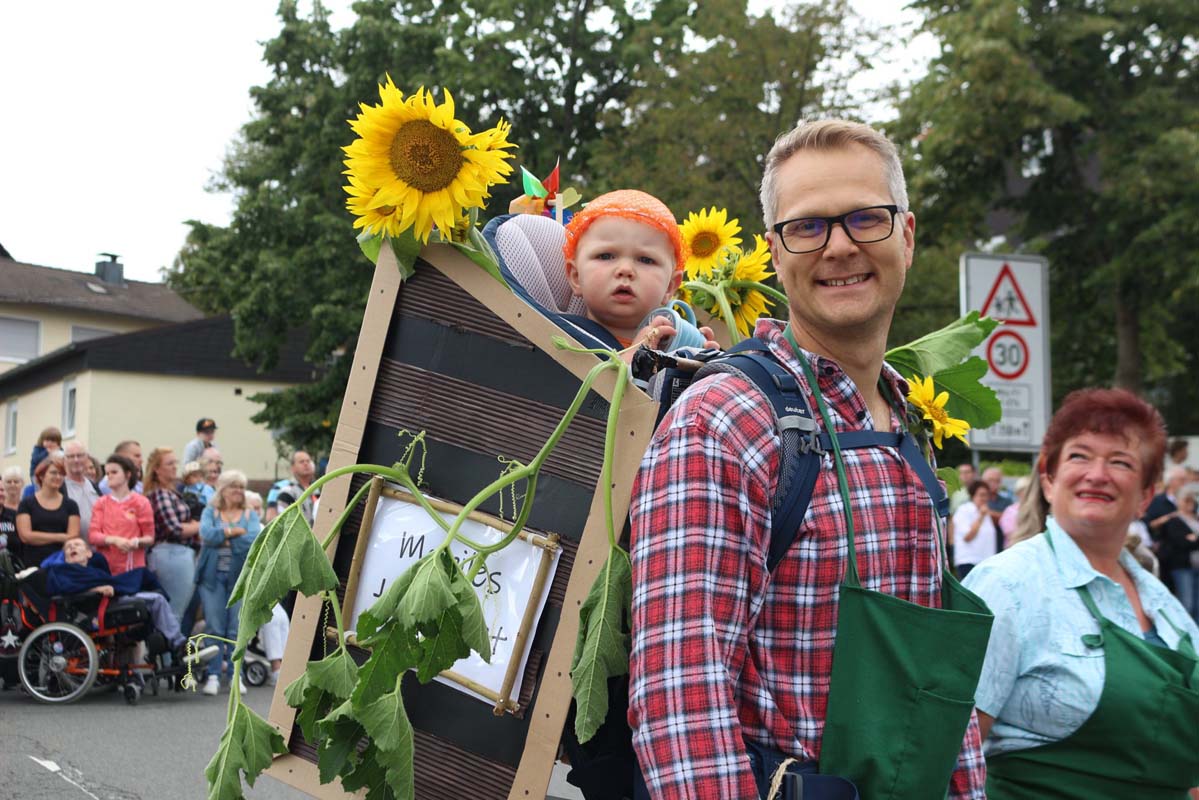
[787,327,993,800]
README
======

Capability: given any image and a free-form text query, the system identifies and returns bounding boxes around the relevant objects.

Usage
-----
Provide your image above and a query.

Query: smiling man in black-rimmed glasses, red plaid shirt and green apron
[628,120,989,800]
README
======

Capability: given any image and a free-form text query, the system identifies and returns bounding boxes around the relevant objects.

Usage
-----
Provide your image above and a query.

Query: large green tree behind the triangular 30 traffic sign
[894,0,1199,419]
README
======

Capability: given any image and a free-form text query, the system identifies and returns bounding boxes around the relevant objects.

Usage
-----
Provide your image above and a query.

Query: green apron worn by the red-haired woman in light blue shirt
[987,531,1199,800]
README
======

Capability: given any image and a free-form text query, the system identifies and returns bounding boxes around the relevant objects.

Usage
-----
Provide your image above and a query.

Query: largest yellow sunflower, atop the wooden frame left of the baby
[343,76,516,242]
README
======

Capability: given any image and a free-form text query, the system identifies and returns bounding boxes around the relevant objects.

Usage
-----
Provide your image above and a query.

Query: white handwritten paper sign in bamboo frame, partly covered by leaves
[349,497,561,703]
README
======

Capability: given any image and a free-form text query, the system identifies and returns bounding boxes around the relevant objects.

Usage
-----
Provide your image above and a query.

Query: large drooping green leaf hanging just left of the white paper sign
[229,504,338,660]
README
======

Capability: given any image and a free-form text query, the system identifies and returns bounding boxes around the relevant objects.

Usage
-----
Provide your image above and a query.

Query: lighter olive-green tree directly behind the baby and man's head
[591,0,879,235]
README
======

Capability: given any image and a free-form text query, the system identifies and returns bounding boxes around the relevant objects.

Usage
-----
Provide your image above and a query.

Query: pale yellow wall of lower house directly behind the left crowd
[0,371,288,480]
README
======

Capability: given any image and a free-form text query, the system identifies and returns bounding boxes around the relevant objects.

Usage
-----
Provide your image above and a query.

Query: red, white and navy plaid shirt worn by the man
[628,321,986,800]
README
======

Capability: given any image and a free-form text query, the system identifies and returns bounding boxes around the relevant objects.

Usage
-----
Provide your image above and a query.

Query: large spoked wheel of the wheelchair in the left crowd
[17,622,100,703]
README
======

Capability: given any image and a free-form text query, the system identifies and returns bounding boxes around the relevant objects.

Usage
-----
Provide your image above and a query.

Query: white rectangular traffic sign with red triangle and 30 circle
[959,253,1053,452]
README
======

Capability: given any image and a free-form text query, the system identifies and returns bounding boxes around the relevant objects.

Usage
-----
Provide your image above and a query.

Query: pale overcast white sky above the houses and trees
[0,0,925,281]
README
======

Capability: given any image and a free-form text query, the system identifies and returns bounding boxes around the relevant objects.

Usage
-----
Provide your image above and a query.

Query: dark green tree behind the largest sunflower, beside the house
[167,0,687,451]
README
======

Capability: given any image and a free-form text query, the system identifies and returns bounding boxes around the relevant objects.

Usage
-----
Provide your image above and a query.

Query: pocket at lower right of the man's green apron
[870,688,974,800]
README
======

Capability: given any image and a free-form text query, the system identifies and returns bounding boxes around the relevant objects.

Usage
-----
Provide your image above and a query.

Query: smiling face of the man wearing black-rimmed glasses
[770,144,916,341]
